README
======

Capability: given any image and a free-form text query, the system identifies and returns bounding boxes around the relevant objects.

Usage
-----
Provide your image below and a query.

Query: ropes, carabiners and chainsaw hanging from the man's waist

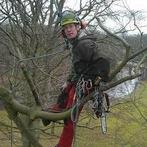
[71,78,110,134]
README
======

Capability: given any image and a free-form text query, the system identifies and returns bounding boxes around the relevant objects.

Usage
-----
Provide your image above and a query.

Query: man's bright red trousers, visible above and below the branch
[57,84,75,147]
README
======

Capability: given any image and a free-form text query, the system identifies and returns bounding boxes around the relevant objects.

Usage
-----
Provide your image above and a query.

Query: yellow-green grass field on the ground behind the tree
[0,82,147,147]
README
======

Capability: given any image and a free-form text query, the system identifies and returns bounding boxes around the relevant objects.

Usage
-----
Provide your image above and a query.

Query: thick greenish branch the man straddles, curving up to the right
[0,74,141,121]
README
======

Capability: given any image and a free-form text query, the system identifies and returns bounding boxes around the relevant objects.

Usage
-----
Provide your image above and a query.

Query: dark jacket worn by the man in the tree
[69,35,110,81]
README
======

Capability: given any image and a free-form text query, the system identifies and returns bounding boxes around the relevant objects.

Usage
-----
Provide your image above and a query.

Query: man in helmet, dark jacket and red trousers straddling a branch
[44,10,110,147]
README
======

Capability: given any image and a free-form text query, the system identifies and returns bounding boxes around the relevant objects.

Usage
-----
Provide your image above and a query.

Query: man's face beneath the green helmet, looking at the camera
[63,23,79,39]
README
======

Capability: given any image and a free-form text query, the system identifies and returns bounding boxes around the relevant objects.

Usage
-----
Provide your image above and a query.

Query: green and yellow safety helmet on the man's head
[60,10,80,26]
